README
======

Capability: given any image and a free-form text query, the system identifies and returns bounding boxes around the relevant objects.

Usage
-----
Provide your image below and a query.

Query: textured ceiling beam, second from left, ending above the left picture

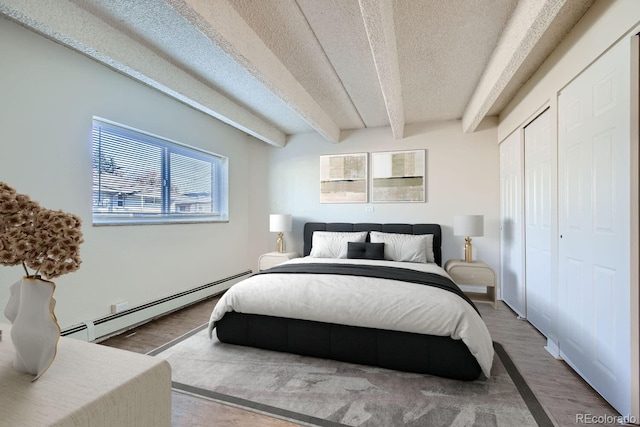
[167,0,340,142]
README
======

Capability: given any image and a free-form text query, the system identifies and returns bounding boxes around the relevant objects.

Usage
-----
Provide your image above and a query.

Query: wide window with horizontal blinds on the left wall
[92,118,228,225]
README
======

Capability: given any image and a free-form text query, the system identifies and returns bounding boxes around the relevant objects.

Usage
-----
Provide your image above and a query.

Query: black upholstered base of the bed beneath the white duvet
[216,312,482,381]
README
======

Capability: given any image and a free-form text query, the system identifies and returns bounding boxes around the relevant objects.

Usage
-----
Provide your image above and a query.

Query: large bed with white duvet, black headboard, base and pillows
[209,222,493,380]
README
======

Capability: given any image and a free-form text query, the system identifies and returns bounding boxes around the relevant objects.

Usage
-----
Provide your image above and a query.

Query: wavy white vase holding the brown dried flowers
[4,277,60,381]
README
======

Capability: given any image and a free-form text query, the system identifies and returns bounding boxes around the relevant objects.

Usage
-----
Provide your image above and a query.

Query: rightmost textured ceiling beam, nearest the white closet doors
[462,0,567,133]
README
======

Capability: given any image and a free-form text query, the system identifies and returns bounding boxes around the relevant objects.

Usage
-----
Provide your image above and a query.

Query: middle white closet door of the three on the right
[524,110,556,341]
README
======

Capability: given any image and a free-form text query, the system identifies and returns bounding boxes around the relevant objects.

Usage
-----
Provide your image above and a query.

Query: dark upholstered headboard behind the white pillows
[304,222,442,266]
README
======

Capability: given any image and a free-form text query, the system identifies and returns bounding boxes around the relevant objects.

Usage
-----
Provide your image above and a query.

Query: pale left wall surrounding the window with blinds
[0,18,267,328]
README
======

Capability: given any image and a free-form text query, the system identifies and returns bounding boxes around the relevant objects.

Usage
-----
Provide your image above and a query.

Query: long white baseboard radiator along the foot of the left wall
[60,270,252,341]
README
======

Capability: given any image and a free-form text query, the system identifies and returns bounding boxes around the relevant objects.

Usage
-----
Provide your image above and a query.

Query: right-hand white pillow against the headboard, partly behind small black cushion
[370,231,436,263]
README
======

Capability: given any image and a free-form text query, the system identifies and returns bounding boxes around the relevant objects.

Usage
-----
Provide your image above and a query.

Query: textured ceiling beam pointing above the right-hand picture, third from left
[359,0,404,139]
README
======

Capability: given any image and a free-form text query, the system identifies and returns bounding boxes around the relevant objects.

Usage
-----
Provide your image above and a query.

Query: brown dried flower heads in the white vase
[0,182,83,279]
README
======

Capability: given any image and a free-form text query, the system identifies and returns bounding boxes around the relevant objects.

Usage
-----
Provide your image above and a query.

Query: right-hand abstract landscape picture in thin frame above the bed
[371,150,427,203]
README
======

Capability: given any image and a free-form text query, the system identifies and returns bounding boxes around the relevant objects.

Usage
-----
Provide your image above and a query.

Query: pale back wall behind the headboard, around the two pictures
[265,120,500,269]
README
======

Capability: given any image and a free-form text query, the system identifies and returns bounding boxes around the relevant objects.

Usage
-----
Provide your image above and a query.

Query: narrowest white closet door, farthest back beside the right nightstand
[500,131,526,317]
